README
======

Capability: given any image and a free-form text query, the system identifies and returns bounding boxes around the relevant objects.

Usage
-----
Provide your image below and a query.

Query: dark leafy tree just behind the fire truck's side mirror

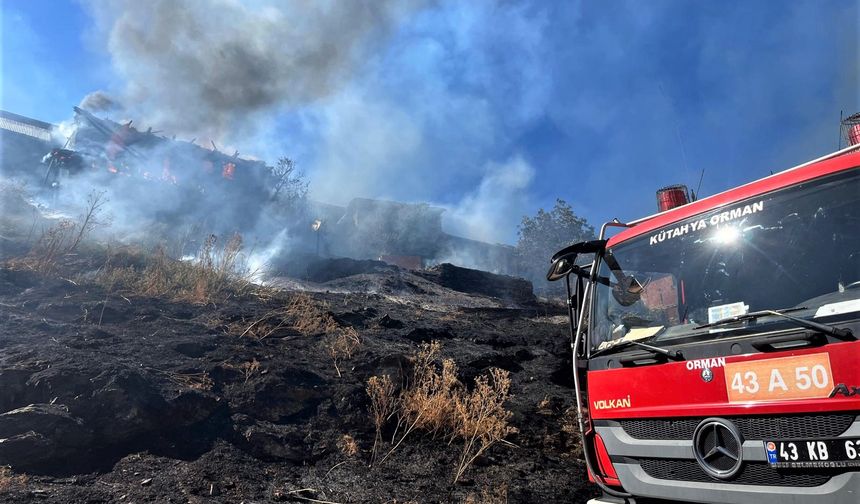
[517,199,594,294]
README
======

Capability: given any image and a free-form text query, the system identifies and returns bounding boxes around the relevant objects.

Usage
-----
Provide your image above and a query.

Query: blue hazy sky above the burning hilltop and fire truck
[0,0,860,242]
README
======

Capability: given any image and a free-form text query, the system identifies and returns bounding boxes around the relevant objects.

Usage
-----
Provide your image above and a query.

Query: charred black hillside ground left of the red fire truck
[0,262,593,503]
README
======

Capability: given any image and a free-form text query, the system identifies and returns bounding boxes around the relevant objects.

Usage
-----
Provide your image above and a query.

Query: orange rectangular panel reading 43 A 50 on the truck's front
[725,352,833,403]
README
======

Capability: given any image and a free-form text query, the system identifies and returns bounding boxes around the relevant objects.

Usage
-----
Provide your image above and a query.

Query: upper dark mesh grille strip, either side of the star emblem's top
[619,414,855,440]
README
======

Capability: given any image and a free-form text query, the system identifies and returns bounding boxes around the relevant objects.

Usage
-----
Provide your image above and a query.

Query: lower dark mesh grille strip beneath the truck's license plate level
[638,459,835,487]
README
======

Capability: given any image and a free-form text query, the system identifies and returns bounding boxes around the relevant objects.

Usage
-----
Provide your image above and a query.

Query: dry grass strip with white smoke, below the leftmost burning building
[96,234,252,304]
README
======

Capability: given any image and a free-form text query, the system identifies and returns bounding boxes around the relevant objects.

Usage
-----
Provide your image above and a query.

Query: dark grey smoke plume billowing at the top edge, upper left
[84,0,423,138]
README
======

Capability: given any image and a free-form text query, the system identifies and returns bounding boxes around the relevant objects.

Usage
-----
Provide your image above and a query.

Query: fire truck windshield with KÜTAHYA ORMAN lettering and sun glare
[590,168,860,350]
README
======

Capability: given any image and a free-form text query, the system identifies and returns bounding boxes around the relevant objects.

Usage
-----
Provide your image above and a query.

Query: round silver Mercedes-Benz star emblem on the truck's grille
[693,418,744,479]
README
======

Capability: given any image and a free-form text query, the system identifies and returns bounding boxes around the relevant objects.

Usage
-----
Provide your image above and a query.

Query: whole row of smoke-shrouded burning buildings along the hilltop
[0,107,517,274]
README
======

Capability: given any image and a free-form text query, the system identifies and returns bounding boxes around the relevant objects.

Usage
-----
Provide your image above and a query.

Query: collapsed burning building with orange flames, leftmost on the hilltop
[0,107,271,241]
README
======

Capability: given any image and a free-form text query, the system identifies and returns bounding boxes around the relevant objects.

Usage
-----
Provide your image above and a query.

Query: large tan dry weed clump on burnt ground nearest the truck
[367,341,516,482]
